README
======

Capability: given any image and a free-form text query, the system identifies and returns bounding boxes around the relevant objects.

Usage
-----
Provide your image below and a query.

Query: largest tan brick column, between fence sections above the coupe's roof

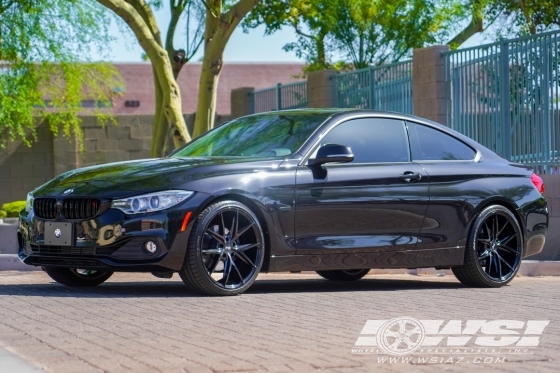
[412,45,449,124]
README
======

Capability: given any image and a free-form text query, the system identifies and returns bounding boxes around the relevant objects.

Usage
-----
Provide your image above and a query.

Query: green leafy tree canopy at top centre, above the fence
[243,0,464,71]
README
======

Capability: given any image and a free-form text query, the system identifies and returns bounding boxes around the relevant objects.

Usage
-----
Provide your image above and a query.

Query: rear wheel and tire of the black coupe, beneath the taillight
[451,205,523,288]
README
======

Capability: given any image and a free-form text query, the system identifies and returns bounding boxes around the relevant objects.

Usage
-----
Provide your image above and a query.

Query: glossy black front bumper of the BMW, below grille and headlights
[18,193,210,272]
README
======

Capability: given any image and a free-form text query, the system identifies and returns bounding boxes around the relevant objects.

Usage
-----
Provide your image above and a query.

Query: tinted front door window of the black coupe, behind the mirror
[321,118,409,163]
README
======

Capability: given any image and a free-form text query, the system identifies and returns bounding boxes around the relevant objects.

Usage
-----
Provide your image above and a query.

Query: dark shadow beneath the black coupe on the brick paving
[0,278,465,298]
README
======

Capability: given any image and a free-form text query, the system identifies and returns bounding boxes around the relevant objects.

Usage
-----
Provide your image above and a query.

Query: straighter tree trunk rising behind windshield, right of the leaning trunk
[193,0,259,137]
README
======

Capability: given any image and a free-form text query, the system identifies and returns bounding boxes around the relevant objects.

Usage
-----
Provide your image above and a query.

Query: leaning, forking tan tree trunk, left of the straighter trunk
[96,0,204,157]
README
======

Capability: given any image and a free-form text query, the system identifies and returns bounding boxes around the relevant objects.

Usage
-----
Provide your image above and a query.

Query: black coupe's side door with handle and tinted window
[295,118,429,255]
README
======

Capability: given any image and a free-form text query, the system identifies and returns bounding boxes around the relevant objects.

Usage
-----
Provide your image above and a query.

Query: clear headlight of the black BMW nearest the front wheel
[111,190,194,214]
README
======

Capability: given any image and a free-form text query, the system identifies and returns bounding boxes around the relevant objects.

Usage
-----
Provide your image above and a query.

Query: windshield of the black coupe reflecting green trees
[173,112,330,157]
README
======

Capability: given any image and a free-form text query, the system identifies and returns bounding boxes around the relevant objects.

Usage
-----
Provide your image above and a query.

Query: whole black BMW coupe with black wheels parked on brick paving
[18,109,548,295]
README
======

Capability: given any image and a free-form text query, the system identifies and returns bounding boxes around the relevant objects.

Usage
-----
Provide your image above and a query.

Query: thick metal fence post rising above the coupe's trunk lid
[499,41,511,160]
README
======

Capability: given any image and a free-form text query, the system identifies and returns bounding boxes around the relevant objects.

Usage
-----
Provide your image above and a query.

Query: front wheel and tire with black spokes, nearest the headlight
[179,201,265,295]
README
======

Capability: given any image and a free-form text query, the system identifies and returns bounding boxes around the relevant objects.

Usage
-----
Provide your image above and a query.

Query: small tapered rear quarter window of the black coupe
[407,123,476,161]
